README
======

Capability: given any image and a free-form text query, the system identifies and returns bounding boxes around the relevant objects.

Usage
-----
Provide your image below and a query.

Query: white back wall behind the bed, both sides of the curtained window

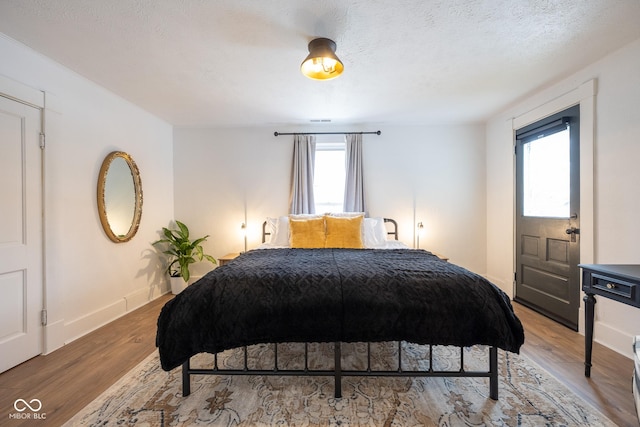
[174,125,486,274]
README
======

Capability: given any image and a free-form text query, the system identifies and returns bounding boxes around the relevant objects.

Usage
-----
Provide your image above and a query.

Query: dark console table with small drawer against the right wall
[578,264,640,377]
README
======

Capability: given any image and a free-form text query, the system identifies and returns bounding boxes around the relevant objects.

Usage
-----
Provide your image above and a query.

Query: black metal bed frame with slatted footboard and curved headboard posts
[182,218,498,400]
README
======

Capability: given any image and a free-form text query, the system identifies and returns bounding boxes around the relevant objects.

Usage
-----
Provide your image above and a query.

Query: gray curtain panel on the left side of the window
[289,135,316,214]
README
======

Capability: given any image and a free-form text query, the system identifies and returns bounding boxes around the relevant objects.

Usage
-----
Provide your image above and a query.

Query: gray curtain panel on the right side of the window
[344,134,366,212]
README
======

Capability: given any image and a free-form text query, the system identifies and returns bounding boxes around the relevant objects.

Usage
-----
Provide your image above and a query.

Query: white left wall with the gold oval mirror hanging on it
[0,34,173,352]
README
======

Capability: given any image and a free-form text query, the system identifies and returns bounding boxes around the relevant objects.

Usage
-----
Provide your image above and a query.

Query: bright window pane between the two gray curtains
[313,140,346,213]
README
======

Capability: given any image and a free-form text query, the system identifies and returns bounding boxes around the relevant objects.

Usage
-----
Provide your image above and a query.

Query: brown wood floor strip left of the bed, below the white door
[0,294,171,427]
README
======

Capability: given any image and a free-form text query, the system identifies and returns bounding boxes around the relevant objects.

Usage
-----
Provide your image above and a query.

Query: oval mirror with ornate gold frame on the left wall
[98,151,142,243]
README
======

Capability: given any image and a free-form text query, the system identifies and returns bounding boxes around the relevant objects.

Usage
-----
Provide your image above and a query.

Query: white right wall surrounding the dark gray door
[487,40,640,356]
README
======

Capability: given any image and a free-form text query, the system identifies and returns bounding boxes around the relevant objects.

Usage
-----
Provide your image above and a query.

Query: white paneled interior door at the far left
[0,96,43,372]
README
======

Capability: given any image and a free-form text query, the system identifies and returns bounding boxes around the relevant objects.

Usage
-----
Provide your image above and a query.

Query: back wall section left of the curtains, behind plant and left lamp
[174,129,292,276]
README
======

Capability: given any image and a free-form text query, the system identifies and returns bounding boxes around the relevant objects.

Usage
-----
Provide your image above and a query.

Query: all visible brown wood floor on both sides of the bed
[0,295,638,427]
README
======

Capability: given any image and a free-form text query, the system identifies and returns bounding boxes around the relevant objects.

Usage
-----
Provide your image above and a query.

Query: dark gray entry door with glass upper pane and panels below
[515,106,580,330]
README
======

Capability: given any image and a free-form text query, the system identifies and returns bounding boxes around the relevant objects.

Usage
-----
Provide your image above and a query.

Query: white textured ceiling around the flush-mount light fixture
[0,0,640,127]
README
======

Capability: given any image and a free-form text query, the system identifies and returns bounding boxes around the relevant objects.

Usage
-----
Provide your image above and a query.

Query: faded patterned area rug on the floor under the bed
[66,343,615,427]
